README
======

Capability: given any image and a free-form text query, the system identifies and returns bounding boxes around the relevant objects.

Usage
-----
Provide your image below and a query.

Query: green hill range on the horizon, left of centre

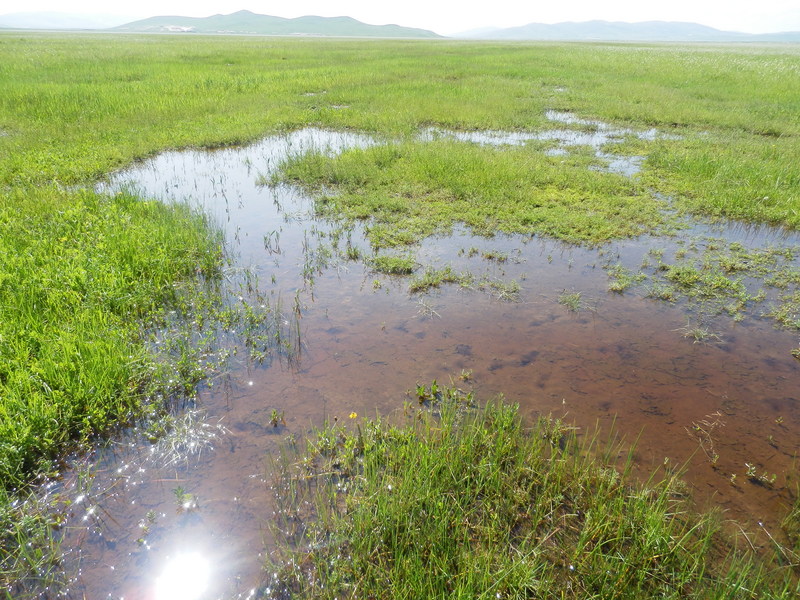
[114,10,442,38]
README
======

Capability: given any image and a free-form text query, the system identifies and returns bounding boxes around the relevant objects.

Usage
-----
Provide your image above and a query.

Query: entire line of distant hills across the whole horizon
[0,10,800,42]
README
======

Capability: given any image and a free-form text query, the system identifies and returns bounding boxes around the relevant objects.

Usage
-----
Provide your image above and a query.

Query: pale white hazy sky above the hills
[6,0,800,35]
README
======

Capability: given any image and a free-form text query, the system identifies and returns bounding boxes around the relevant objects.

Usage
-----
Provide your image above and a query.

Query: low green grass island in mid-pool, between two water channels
[280,140,663,248]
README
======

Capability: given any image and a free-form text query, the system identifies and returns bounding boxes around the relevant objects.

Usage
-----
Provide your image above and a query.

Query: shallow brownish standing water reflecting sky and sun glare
[43,123,800,599]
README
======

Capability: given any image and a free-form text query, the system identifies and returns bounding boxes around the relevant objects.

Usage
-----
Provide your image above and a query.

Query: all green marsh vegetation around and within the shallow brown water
[0,32,800,597]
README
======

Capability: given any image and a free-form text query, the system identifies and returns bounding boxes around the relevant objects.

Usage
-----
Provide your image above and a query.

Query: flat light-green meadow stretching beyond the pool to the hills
[0,34,800,218]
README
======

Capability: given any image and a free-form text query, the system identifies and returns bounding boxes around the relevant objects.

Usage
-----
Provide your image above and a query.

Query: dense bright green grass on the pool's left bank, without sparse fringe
[0,188,221,489]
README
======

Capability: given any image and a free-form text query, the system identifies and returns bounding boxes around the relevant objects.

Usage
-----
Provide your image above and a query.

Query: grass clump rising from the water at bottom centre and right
[265,388,798,599]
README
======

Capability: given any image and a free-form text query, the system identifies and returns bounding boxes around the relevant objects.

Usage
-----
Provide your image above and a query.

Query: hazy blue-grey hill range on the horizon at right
[453,21,800,42]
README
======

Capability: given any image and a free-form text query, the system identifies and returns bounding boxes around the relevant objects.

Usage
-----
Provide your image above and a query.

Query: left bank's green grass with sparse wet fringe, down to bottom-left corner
[0,187,222,598]
